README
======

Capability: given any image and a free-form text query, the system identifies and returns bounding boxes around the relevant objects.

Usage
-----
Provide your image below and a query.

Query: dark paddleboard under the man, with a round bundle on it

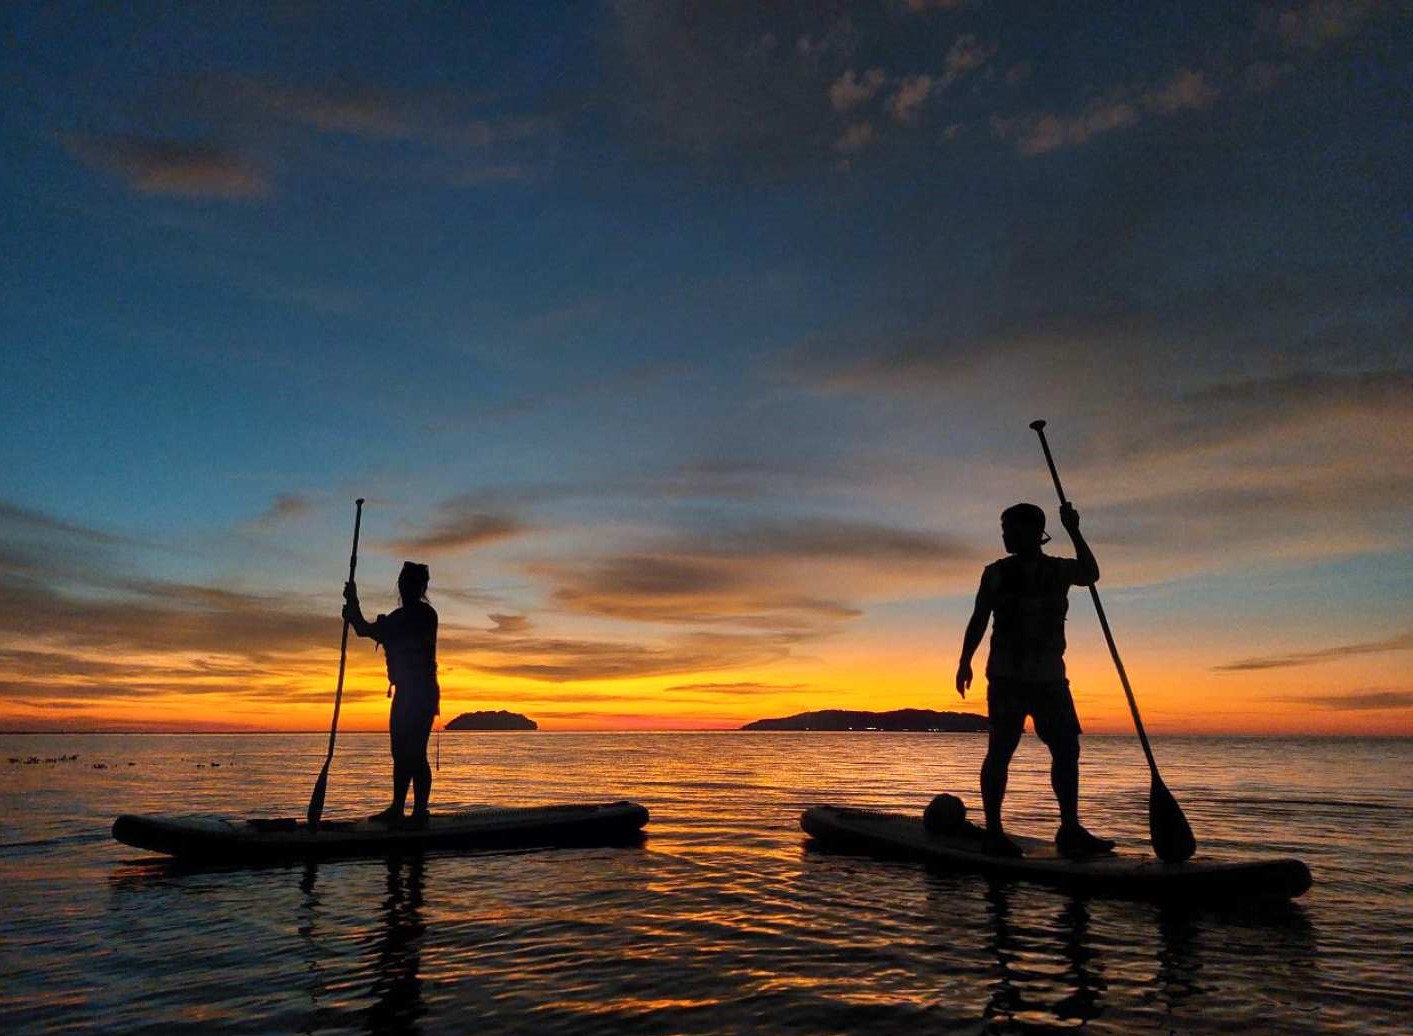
[800,806,1310,903]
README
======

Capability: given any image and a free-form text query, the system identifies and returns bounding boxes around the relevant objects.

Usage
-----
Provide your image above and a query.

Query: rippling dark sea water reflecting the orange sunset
[0,732,1413,1035]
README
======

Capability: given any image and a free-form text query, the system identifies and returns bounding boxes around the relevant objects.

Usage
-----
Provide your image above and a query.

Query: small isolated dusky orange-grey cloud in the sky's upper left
[68,136,270,199]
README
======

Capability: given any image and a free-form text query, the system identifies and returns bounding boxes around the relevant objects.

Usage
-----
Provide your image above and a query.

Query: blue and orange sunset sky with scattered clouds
[0,0,1413,735]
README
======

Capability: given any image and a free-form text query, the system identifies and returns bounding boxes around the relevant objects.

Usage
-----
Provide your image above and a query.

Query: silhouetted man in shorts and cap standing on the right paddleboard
[957,503,1113,857]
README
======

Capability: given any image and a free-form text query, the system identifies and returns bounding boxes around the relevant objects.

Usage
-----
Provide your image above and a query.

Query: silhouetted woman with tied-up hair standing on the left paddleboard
[343,561,441,827]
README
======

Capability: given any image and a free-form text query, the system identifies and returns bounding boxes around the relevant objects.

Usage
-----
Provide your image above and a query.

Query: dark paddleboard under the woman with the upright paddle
[113,801,647,864]
